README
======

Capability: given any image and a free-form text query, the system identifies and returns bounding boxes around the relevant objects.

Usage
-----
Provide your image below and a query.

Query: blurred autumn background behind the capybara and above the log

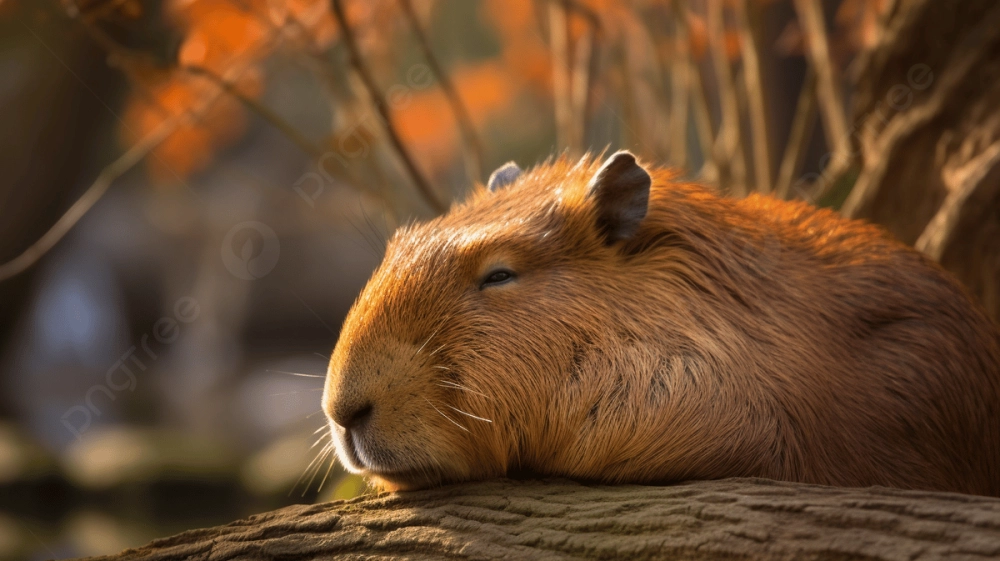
[0,0,1000,559]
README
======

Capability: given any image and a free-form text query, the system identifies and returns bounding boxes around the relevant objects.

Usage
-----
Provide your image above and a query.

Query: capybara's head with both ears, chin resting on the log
[323,152,651,489]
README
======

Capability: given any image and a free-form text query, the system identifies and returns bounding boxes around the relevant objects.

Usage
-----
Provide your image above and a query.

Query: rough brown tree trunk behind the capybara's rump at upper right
[843,0,1000,321]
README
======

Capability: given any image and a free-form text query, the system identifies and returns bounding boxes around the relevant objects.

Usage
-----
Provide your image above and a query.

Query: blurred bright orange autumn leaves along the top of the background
[84,0,887,188]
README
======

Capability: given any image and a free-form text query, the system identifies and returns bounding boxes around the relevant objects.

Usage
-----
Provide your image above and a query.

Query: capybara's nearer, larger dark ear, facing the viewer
[587,150,652,245]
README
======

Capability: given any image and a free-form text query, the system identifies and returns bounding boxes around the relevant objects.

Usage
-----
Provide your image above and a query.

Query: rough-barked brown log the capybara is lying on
[94,479,1000,561]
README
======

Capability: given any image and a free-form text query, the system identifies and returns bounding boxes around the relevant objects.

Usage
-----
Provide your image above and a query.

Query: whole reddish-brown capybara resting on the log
[324,153,1000,496]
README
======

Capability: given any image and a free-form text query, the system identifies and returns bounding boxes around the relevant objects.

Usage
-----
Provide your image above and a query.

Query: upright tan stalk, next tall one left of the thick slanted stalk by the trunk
[735,0,771,193]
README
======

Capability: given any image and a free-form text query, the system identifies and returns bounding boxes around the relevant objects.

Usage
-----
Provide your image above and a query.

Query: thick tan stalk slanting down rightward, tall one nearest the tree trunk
[795,0,850,190]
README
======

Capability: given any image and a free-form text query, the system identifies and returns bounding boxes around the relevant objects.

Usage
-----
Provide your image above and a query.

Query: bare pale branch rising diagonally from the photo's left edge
[0,106,201,281]
